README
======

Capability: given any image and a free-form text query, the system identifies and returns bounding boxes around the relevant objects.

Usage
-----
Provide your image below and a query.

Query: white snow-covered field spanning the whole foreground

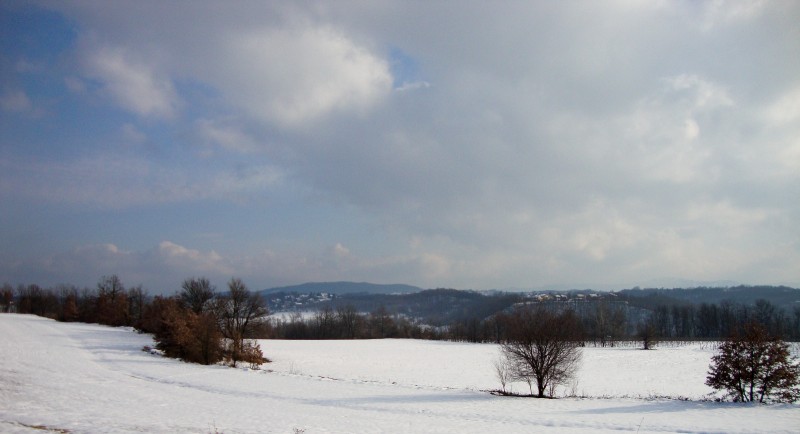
[0,314,800,434]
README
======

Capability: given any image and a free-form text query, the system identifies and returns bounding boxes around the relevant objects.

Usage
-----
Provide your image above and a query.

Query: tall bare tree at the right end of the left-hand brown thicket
[216,278,269,366]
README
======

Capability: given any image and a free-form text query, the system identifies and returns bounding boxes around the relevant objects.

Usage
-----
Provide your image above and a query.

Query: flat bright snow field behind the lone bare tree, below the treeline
[261,339,713,400]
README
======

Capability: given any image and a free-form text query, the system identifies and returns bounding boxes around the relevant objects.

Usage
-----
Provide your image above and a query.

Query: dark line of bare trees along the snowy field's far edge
[269,300,800,348]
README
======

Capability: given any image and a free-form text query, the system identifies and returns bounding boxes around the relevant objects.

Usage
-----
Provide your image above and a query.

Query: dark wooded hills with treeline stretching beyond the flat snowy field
[270,287,800,346]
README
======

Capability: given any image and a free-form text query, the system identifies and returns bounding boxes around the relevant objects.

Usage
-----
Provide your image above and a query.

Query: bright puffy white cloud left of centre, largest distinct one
[206,26,392,127]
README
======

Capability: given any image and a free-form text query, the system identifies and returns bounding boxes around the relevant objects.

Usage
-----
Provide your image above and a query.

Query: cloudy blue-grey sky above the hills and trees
[0,0,800,293]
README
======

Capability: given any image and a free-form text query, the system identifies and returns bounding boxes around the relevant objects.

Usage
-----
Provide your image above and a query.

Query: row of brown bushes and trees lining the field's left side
[0,275,269,366]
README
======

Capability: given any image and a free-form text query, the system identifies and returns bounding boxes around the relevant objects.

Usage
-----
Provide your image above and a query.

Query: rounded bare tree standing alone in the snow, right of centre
[501,306,583,398]
